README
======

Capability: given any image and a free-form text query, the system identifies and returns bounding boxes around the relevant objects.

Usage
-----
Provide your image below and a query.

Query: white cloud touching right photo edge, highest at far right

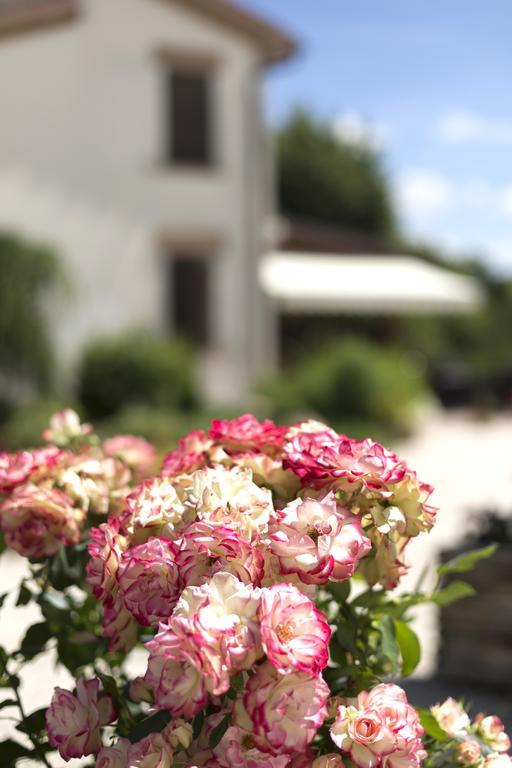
[434,111,512,144]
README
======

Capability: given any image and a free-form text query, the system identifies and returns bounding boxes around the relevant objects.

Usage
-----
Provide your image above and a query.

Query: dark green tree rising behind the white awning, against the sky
[277,110,394,237]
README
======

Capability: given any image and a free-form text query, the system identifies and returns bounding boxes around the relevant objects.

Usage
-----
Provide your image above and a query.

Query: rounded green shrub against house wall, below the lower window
[77,333,197,419]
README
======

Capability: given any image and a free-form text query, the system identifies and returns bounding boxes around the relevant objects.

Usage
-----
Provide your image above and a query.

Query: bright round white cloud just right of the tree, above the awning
[395,168,455,218]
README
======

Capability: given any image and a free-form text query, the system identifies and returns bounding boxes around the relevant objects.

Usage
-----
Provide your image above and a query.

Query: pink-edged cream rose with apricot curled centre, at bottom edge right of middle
[331,684,426,768]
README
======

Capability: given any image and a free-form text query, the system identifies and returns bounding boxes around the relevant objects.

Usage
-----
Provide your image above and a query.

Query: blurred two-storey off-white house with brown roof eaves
[0,0,294,400]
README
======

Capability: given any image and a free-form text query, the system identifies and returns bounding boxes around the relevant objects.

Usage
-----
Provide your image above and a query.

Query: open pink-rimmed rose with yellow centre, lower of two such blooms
[258,584,331,677]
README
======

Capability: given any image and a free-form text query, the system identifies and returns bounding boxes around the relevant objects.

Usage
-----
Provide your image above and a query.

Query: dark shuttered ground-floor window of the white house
[169,253,211,347]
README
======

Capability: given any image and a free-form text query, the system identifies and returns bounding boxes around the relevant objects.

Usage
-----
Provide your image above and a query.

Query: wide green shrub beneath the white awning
[265,337,427,431]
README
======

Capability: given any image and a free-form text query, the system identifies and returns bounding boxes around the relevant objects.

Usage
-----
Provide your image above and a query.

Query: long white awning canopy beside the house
[260,251,483,315]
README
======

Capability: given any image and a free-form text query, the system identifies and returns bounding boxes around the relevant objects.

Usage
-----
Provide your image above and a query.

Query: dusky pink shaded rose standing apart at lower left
[46,677,117,761]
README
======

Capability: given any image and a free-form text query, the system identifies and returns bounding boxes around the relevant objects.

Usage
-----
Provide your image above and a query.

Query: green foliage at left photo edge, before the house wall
[0,233,61,399]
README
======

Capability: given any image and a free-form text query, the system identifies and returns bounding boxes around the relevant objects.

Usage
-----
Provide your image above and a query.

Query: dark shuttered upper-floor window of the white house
[165,69,212,166]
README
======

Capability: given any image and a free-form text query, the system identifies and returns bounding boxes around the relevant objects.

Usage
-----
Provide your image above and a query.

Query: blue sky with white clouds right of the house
[241,0,512,275]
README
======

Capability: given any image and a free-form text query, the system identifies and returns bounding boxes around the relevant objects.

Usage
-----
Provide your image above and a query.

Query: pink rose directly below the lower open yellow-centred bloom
[234,661,329,755]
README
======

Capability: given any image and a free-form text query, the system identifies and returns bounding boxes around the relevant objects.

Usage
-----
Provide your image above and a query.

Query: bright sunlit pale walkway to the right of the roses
[395,404,512,677]
